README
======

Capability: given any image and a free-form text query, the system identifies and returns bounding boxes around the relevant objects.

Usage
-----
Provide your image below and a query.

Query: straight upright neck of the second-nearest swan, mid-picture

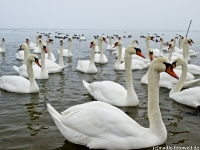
[125,51,139,104]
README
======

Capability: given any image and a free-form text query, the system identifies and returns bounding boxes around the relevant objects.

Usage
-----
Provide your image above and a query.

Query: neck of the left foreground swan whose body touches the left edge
[26,60,37,89]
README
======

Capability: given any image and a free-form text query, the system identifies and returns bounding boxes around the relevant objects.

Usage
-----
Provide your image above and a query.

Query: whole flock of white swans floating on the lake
[0,35,200,149]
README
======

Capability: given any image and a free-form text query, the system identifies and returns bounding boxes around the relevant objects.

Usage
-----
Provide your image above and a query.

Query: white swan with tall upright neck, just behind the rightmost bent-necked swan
[177,39,200,75]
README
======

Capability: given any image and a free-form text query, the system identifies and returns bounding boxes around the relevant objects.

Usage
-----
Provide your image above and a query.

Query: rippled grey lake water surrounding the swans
[0,29,200,150]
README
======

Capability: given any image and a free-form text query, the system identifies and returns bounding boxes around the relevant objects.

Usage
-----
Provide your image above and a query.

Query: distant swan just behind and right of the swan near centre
[94,36,108,64]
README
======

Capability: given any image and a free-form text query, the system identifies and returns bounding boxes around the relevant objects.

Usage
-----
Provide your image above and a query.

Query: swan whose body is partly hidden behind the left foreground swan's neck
[13,40,49,79]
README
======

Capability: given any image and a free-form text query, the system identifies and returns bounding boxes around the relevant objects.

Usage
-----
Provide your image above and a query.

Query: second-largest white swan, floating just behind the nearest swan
[83,45,145,106]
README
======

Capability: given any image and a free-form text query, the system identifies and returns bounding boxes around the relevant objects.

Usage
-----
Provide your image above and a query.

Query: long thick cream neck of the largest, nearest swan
[148,65,166,134]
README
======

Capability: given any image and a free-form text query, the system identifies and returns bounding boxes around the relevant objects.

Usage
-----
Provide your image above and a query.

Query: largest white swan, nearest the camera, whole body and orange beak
[47,58,177,149]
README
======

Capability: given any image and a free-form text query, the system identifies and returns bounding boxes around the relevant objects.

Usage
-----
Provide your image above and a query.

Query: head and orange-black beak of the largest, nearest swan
[149,57,179,79]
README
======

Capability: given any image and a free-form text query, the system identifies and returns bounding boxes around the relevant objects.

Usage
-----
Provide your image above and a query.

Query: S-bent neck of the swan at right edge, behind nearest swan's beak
[169,63,187,97]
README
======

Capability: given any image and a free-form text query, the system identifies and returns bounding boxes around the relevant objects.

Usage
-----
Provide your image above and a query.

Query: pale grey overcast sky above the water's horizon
[0,0,200,30]
